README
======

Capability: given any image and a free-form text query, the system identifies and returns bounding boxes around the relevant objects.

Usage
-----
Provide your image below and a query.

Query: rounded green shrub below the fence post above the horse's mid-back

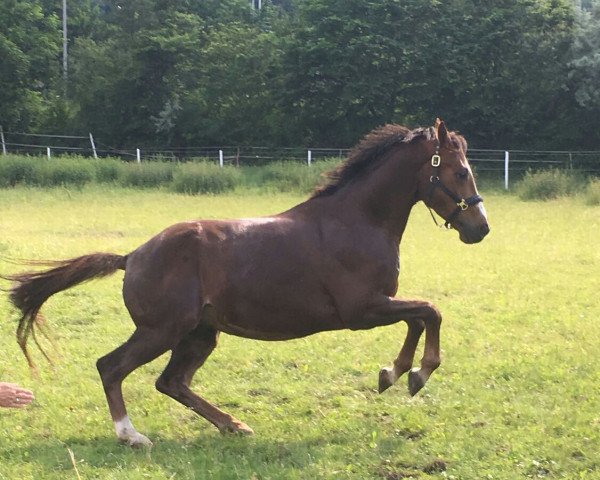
[172,162,242,195]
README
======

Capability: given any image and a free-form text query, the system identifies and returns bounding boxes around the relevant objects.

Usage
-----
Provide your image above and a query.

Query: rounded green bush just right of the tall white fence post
[517,170,581,200]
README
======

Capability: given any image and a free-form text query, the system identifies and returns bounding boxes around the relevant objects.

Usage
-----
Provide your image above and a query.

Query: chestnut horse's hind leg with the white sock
[96,328,172,447]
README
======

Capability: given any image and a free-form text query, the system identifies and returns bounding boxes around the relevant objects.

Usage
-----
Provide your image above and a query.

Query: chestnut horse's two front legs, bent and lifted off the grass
[364,297,442,395]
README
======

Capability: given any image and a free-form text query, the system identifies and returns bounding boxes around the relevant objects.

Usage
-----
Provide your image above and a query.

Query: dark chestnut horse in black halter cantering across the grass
[4,120,489,446]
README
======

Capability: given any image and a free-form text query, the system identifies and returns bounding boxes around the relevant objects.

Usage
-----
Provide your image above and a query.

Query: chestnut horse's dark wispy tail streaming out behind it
[2,253,127,371]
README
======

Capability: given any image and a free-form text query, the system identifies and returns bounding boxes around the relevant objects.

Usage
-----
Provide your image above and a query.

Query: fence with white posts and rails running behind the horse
[0,127,600,189]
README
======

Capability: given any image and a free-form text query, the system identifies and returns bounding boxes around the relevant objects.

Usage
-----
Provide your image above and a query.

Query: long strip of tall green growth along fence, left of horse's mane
[0,155,340,194]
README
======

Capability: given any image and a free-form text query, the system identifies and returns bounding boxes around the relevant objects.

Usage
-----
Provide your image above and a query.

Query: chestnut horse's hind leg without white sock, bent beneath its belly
[156,314,254,434]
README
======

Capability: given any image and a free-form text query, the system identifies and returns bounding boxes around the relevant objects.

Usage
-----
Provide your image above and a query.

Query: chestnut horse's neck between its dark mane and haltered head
[316,145,425,242]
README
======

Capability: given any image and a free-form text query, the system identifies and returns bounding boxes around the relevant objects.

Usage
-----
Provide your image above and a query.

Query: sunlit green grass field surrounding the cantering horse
[0,187,600,480]
